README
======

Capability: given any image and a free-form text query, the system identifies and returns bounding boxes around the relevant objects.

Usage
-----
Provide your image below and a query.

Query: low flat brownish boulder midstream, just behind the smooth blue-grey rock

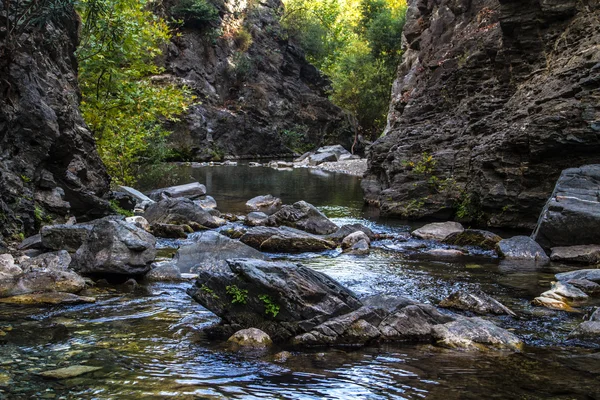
[240,227,335,253]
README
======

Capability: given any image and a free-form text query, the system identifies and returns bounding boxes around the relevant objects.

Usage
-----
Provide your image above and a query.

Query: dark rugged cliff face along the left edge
[0,5,109,239]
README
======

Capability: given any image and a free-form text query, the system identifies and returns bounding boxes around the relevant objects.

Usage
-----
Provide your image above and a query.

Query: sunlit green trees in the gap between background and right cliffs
[282,0,406,136]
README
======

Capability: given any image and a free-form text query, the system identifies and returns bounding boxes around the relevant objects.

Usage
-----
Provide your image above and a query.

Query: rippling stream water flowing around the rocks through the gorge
[0,166,600,400]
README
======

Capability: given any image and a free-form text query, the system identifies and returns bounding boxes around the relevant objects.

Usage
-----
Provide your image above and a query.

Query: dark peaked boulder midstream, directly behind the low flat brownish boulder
[268,201,339,235]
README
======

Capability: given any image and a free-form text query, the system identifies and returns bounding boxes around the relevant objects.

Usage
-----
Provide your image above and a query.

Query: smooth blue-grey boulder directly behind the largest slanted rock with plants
[174,231,269,273]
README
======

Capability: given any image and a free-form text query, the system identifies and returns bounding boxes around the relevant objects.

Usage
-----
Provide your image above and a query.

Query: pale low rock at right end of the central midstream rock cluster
[432,317,523,351]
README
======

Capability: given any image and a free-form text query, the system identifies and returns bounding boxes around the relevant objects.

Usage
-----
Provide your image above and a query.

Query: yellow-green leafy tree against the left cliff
[77,0,193,184]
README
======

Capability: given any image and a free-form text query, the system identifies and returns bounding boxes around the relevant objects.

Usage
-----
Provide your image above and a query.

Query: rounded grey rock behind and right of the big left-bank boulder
[144,197,227,228]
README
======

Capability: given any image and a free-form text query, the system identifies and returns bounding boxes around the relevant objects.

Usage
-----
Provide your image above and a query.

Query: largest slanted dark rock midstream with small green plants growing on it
[188,259,362,340]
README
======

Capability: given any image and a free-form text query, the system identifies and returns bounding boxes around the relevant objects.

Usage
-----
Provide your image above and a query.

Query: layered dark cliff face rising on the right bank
[363,0,600,228]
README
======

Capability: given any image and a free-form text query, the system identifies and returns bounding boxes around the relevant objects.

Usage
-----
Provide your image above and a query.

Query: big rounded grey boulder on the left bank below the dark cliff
[73,217,156,275]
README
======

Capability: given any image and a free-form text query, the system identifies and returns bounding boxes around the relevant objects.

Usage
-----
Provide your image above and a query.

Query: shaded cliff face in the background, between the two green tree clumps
[165,0,354,161]
